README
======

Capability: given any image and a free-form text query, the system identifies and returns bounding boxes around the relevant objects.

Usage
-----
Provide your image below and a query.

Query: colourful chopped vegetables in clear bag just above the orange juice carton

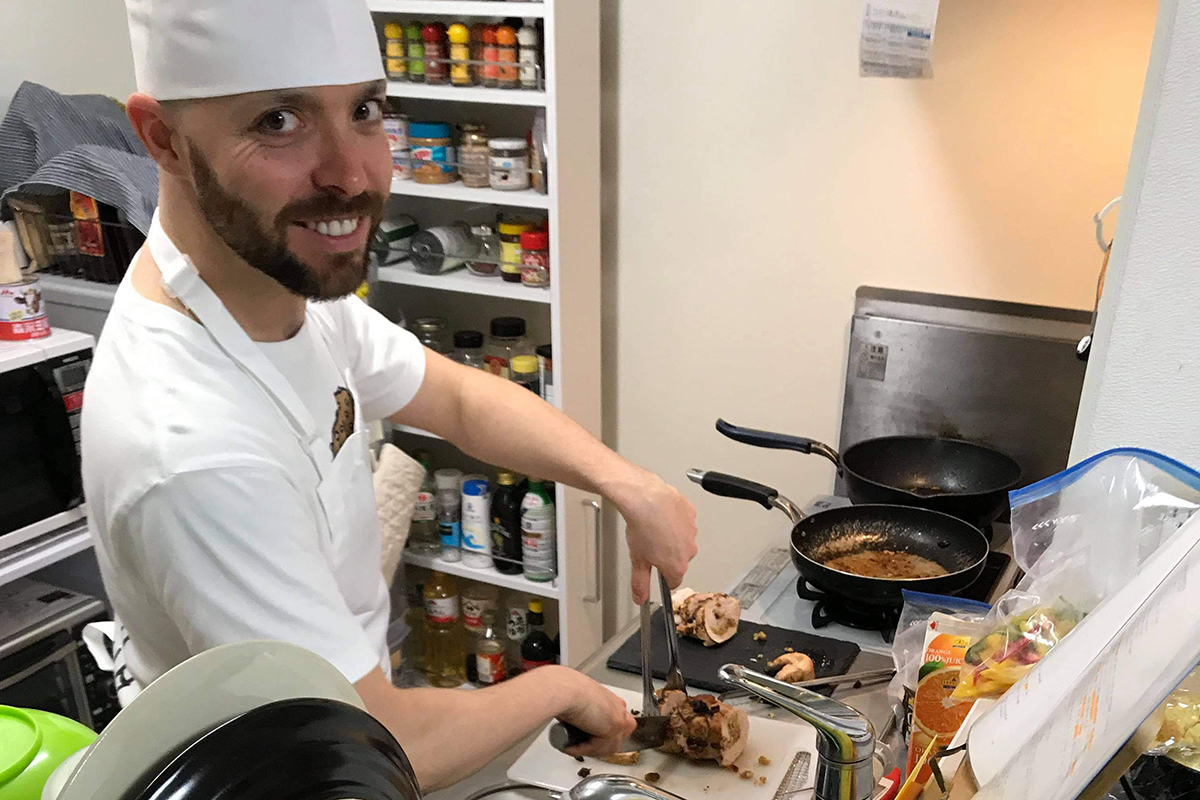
[952,591,1082,700]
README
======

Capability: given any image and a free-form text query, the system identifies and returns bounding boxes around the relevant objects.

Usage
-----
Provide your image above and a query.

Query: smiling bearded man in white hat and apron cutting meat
[83,0,695,788]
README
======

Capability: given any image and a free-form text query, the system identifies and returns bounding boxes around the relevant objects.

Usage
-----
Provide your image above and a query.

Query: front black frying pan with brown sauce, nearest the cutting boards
[688,470,988,606]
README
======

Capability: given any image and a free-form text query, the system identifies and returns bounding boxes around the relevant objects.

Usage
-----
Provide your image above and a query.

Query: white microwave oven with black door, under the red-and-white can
[0,329,94,551]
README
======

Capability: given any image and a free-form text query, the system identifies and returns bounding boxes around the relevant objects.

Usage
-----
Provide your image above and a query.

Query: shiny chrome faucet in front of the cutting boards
[716,664,875,800]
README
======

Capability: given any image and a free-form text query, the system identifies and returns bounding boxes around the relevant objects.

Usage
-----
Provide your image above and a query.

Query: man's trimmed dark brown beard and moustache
[188,144,384,300]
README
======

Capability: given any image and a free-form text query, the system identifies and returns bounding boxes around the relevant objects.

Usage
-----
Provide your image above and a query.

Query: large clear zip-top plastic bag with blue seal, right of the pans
[953,447,1200,700]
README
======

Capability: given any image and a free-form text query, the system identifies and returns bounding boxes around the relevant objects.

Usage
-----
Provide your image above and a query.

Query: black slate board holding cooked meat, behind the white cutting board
[608,608,859,693]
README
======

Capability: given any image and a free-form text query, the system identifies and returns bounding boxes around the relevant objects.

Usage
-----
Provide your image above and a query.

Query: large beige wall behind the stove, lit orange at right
[604,0,1156,616]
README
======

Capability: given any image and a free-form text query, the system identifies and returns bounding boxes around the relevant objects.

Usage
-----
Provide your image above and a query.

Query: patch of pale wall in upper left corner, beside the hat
[0,0,134,116]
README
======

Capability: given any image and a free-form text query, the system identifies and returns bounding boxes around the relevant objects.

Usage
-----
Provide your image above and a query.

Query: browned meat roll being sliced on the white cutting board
[658,688,750,766]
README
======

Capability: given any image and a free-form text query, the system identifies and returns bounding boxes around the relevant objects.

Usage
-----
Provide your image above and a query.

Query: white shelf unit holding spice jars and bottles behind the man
[370,0,604,664]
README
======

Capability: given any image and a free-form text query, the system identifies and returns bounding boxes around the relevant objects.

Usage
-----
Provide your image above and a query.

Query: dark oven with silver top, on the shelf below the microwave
[0,578,120,732]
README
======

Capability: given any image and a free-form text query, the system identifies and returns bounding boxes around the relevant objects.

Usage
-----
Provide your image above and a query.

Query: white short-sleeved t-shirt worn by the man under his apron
[82,272,425,685]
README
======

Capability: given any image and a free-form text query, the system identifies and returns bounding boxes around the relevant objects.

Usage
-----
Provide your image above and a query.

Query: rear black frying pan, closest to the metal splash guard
[716,420,1021,528]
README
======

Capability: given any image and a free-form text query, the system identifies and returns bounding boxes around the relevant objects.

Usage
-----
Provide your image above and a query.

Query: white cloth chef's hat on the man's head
[125,0,384,100]
